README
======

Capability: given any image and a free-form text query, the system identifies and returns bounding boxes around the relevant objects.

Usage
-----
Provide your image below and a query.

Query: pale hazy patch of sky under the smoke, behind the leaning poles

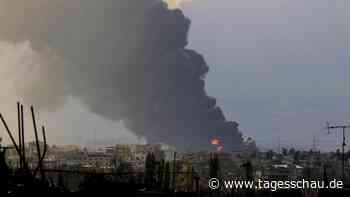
[0,42,144,146]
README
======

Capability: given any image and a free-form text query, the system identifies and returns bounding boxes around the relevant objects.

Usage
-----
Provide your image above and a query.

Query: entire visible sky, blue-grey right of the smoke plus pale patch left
[0,0,350,150]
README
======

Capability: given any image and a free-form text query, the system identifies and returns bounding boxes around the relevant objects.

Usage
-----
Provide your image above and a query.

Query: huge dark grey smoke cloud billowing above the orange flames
[0,0,242,150]
